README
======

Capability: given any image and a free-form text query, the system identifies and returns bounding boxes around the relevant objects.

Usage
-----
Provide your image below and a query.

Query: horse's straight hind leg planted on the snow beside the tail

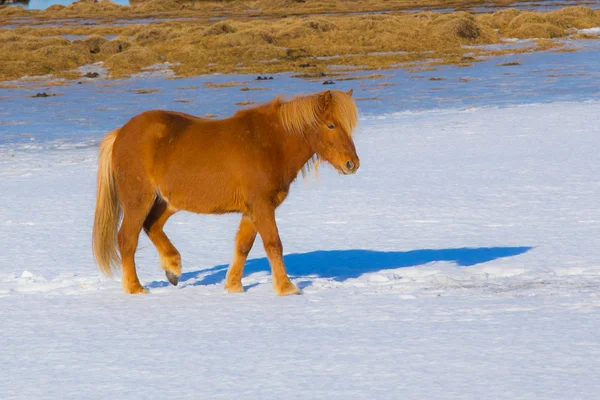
[119,190,154,294]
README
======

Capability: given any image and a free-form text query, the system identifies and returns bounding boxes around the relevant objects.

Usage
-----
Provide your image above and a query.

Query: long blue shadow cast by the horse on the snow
[149,247,532,288]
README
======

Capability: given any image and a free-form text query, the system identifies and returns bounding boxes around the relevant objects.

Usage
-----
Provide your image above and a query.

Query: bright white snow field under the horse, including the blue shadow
[0,96,600,399]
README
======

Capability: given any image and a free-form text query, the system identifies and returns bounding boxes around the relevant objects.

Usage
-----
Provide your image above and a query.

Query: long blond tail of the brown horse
[92,129,122,276]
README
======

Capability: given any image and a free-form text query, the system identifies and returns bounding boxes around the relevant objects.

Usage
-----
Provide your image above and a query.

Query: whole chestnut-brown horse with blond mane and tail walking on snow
[93,90,359,295]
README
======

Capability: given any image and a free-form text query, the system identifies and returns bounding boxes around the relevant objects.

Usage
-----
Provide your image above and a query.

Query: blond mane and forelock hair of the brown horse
[276,90,358,178]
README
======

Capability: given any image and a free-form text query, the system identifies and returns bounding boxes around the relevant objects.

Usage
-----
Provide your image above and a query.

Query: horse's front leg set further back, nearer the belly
[225,215,256,293]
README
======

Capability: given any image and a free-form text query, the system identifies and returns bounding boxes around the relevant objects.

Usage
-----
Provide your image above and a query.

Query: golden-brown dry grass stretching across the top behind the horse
[0,0,600,81]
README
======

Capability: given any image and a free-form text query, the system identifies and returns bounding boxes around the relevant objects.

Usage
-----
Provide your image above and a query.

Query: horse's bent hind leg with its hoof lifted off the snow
[144,197,181,286]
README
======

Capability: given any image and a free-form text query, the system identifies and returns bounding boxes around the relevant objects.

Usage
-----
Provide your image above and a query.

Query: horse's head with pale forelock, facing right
[311,90,360,175]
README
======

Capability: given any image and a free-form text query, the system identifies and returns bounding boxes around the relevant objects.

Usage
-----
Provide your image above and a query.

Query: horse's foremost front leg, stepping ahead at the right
[252,205,300,296]
